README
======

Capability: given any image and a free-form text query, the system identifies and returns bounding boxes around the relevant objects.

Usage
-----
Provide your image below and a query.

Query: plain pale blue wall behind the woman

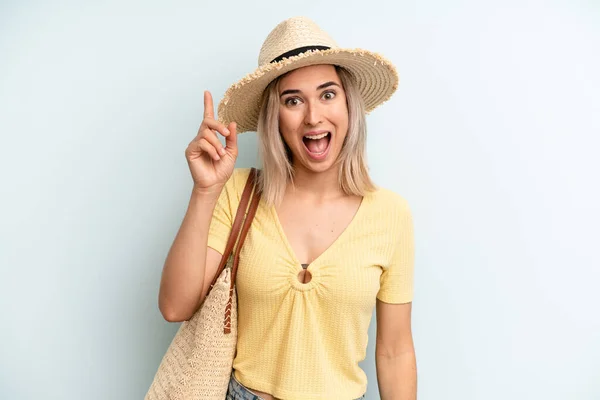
[0,0,600,400]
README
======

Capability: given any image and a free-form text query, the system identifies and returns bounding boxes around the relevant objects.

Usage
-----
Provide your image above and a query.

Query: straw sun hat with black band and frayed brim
[218,17,398,133]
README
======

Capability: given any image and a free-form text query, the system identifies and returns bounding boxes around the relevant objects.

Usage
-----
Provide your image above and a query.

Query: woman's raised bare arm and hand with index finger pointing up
[158,91,238,322]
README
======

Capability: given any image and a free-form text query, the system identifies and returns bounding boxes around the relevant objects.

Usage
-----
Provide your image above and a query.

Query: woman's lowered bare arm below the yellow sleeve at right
[375,299,417,400]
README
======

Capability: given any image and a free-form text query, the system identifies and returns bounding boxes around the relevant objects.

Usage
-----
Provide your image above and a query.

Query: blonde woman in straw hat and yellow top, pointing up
[159,18,416,400]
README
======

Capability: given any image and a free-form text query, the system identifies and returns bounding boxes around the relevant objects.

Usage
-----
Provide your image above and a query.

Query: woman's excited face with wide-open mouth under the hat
[278,65,348,172]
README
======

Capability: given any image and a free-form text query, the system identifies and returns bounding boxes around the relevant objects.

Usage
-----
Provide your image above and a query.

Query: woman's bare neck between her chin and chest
[286,165,344,201]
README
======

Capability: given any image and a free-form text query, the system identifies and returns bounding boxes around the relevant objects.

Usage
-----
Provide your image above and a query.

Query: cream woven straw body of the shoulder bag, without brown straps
[145,264,237,400]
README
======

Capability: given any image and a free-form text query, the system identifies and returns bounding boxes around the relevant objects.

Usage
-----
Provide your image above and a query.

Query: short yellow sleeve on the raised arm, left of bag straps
[208,169,250,254]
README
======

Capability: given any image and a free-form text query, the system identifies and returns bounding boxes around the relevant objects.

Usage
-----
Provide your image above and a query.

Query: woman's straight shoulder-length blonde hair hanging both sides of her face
[257,66,375,205]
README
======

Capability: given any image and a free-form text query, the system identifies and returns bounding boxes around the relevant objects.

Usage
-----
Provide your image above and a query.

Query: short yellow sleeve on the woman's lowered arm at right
[377,199,415,304]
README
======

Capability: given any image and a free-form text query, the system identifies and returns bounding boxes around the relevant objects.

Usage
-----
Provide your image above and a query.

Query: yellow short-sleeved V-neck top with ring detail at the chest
[208,169,414,400]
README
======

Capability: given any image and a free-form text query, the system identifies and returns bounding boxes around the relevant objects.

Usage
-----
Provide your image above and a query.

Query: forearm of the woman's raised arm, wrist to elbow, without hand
[158,189,220,321]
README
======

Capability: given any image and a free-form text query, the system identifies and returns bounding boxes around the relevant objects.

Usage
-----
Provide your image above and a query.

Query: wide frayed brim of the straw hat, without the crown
[217,49,398,133]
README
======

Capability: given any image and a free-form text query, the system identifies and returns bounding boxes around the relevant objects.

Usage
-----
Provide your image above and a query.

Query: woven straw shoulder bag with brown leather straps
[144,168,260,400]
